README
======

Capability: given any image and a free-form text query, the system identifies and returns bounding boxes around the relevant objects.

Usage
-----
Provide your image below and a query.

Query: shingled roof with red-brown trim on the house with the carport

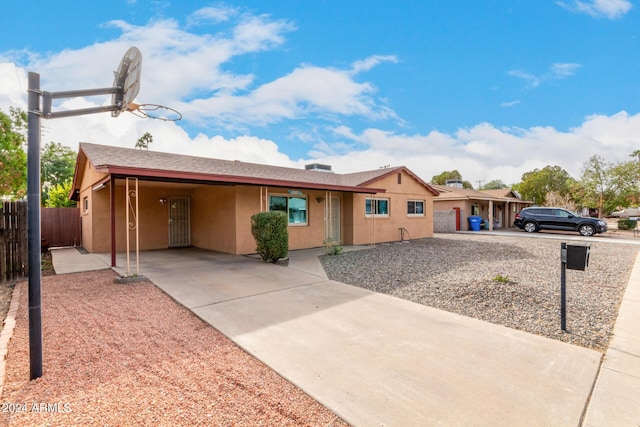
[74,142,437,194]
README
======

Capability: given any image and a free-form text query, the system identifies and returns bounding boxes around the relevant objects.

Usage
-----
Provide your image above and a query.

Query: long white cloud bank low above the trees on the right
[310,112,640,183]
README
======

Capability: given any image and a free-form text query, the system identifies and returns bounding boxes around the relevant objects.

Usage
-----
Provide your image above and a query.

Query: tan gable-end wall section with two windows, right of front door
[352,172,434,245]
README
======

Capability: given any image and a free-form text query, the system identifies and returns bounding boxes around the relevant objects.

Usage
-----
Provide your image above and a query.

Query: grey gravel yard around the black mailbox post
[321,234,640,352]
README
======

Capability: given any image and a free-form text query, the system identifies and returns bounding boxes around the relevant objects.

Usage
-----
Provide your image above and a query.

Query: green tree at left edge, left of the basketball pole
[0,107,27,198]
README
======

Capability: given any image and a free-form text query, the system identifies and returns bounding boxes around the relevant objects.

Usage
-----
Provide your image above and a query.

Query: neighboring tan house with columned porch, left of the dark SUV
[432,185,533,232]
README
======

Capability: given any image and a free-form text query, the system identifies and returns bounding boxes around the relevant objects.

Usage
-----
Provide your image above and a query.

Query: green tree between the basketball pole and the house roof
[40,141,76,206]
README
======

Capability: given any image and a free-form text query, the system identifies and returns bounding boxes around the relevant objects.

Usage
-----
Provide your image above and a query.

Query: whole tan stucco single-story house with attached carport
[71,143,438,263]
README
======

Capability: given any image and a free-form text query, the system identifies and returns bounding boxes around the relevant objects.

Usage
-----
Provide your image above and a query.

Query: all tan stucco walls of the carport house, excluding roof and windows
[80,162,433,254]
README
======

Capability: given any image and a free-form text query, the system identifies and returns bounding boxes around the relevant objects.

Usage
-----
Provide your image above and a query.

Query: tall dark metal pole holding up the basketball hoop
[27,72,42,380]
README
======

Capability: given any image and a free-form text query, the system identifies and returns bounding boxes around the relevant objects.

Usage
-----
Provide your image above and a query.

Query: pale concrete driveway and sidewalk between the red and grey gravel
[54,244,640,426]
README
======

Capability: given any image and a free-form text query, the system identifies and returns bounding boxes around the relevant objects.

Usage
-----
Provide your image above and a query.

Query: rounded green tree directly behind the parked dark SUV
[517,166,573,205]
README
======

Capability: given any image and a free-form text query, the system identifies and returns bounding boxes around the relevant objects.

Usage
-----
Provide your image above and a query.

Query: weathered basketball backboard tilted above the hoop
[111,47,142,117]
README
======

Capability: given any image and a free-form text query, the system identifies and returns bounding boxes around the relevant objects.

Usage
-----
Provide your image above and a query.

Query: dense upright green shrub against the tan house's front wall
[251,211,289,262]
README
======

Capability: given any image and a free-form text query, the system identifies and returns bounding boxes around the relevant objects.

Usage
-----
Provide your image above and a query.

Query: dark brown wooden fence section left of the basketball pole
[0,201,29,282]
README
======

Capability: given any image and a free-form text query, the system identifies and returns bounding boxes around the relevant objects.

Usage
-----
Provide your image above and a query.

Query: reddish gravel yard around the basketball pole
[0,270,346,426]
